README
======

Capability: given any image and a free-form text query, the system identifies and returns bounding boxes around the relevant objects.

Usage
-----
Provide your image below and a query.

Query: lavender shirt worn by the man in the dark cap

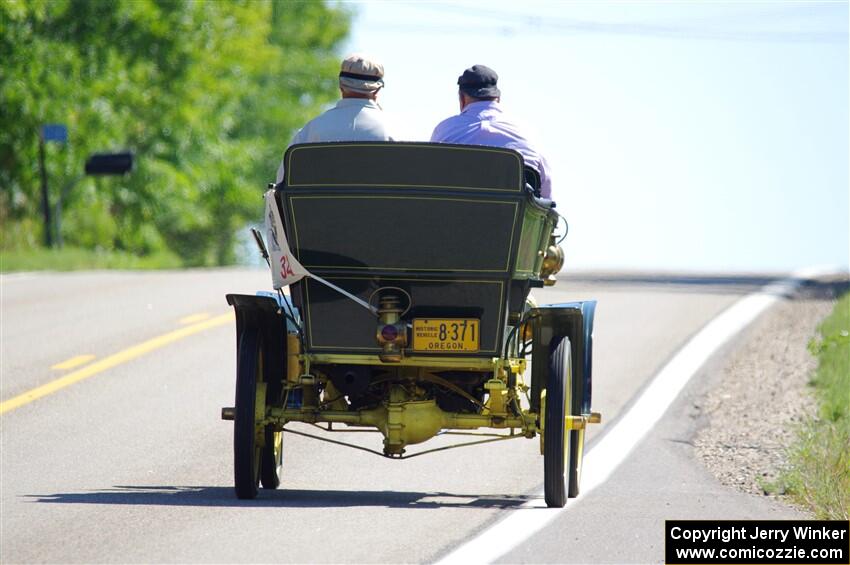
[431,100,552,198]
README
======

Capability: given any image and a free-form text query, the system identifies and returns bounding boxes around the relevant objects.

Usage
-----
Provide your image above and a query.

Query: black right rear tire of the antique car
[543,336,572,508]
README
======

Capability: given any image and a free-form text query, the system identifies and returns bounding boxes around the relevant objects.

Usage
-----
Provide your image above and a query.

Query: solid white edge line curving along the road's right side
[436,267,842,565]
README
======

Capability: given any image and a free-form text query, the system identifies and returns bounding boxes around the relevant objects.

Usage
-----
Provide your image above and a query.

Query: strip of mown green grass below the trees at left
[0,247,183,273]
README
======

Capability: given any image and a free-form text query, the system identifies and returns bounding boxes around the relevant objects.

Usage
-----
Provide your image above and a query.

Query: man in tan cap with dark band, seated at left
[277,54,393,183]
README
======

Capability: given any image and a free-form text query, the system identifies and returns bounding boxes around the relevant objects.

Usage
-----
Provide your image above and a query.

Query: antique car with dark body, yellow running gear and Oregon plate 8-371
[222,143,600,507]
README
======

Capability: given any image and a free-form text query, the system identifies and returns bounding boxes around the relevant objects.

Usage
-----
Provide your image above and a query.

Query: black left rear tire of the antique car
[233,328,262,499]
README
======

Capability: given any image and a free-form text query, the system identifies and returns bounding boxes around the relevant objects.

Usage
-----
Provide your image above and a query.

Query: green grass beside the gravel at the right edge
[775,293,850,520]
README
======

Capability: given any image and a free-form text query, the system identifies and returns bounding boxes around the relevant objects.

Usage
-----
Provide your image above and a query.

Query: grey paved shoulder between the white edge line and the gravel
[499,285,831,563]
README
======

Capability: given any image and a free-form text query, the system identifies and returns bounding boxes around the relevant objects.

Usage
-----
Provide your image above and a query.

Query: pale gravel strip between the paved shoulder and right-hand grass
[691,278,847,505]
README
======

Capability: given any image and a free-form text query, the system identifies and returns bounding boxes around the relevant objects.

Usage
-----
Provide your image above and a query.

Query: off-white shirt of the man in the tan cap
[277,98,394,183]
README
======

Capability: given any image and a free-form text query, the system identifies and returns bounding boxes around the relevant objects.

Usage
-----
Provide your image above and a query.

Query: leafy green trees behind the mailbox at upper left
[0,0,350,264]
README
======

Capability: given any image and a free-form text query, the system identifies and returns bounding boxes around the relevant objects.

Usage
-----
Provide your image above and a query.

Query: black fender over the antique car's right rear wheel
[526,300,596,416]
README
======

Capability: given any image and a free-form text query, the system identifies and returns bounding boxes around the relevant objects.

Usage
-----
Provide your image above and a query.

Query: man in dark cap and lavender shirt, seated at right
[431,65,552,198]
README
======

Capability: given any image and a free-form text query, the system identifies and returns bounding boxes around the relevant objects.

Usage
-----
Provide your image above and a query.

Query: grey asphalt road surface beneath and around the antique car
[0,270,794,563]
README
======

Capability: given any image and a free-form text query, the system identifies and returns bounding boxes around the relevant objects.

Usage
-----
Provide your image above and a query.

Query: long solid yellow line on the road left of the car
[0,312,233,414]
